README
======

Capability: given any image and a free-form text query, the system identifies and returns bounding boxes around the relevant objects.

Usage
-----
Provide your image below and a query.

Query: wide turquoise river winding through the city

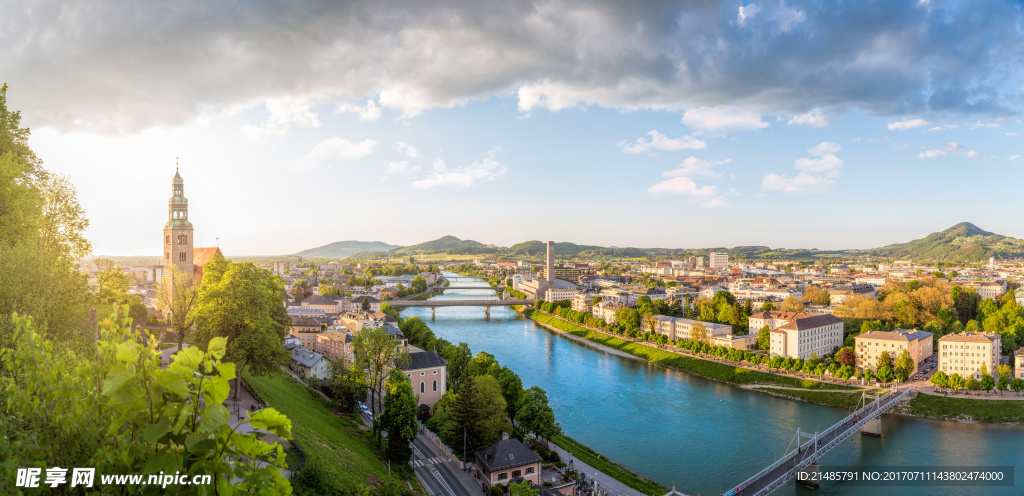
[401,274,1024,496]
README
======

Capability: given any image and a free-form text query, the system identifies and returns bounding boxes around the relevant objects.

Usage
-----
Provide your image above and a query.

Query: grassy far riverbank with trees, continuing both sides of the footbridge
[515,306,1024,423]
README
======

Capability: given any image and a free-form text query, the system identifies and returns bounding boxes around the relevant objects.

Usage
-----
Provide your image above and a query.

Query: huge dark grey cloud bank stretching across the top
[0,0,1024,135]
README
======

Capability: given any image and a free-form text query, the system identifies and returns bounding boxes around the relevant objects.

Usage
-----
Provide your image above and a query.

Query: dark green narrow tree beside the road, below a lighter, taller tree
[379,369,419,463]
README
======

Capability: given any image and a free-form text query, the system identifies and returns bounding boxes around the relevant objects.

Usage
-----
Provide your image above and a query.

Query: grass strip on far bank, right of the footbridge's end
[901,394,1024,422]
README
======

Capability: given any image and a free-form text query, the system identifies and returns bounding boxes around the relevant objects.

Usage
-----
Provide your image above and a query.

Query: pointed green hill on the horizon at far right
[868,222,1024,261]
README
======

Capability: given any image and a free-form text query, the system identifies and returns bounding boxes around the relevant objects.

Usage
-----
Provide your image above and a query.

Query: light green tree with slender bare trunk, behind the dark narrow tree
[352,327,409,441]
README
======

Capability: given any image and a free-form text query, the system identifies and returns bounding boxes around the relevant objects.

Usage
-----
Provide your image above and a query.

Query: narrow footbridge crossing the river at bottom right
[723,387,910,496]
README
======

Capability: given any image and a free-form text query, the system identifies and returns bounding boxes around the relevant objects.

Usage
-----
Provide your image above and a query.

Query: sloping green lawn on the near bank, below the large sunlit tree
[245,373,405,488]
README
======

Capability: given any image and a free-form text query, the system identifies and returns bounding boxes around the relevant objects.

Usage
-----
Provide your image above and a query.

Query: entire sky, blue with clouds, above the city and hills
[0,0,1024,256]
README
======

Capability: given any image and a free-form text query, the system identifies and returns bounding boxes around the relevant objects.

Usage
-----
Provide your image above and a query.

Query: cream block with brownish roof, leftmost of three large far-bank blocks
[770,315,843,360]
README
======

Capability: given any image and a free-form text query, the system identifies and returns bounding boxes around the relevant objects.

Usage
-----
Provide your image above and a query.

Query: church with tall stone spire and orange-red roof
[163,168,224,286]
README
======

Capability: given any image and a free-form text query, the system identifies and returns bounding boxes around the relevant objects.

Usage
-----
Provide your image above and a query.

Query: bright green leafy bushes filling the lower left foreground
[0,314,292,494]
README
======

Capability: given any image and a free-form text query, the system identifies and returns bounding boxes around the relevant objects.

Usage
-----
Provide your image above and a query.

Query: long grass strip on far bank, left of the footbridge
[521,308,855,390]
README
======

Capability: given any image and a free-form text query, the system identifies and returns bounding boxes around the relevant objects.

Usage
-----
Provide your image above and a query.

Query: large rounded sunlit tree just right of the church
[195,256,292,401]
